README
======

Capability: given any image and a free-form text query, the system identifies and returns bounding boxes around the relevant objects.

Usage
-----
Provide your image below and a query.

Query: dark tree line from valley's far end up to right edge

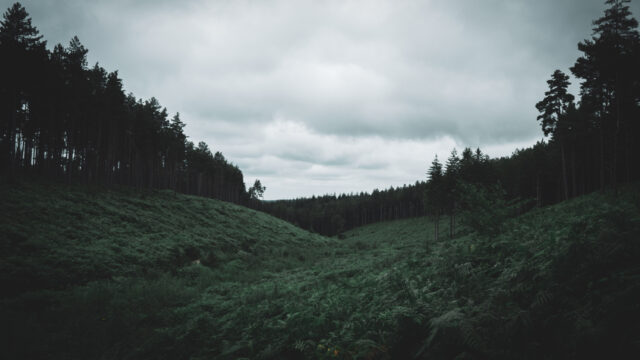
[262,0,640,236]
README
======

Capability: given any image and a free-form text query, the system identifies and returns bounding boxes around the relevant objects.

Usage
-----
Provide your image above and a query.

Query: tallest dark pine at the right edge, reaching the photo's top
[571,0,640,189]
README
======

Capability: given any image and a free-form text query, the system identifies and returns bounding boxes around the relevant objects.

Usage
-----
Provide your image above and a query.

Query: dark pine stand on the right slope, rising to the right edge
[427,0,640,237]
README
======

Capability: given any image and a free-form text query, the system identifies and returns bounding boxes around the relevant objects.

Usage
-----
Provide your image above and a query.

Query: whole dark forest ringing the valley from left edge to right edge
[0,0,640,235]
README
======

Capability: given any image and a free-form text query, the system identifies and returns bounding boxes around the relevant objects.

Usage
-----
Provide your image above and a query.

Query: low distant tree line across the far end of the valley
[254,148,498,236]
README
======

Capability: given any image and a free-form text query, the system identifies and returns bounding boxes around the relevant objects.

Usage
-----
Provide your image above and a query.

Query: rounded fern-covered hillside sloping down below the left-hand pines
[0,184,330,291]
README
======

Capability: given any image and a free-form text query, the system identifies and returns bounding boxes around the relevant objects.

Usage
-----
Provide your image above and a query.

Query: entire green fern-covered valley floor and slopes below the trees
[0,185,640,358]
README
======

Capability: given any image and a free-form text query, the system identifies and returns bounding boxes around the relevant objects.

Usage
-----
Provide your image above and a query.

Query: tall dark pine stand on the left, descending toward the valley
[0,3,248,203]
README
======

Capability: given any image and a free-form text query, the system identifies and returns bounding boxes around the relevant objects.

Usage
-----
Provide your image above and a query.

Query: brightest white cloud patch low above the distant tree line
[215,118,532,199]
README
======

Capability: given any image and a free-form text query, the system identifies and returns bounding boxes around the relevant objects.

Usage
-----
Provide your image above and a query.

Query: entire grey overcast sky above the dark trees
[6,0,638,199]
